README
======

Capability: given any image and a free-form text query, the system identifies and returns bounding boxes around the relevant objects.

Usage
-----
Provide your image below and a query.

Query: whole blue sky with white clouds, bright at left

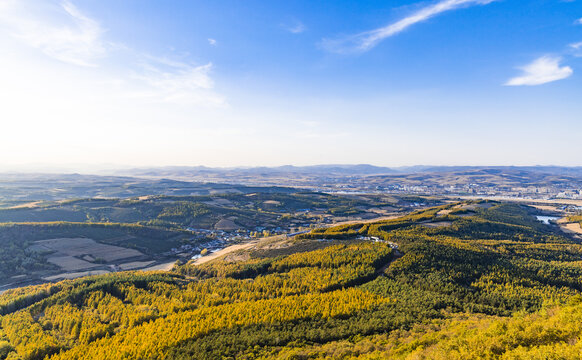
[0,0,582,170]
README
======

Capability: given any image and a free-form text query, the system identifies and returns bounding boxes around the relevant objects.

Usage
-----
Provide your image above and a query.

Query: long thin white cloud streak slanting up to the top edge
[322,0,495,53]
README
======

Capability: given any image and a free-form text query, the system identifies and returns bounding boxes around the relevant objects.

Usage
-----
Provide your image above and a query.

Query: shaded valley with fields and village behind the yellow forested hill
[0,186,442,291]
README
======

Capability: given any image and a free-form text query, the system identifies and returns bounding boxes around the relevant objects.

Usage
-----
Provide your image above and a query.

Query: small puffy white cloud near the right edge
[505,56,574,86]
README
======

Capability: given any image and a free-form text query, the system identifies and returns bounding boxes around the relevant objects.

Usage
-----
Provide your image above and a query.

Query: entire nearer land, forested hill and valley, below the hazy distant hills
[0,169,582,360]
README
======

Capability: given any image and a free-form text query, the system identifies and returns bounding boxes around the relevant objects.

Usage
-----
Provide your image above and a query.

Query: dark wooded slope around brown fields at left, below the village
[0,222,197,290]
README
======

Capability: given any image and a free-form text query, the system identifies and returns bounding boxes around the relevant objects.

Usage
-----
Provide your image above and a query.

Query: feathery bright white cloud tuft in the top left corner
[0,0,106,66]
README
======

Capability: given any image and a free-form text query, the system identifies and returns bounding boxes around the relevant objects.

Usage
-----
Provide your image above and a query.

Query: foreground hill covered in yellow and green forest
[0,202,582,360]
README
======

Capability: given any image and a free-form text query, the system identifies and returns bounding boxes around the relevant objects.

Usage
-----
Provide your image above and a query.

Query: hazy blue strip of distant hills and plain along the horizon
[0,164,582,202]
